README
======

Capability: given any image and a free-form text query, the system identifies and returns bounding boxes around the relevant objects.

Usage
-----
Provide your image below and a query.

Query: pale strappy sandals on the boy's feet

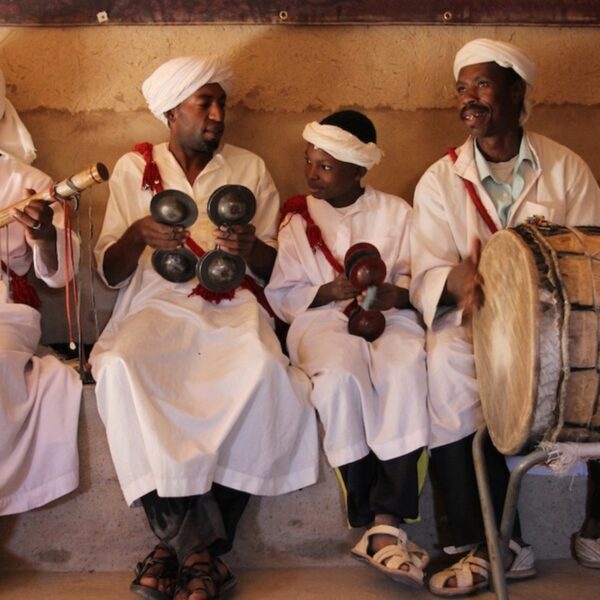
[350,525,429,588]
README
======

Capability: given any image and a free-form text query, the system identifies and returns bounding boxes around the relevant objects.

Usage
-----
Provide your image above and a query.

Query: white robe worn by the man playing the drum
[411,132,600,447]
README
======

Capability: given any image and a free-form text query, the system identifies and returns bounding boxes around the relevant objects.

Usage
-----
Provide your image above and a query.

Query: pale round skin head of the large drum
[473,230,539,454]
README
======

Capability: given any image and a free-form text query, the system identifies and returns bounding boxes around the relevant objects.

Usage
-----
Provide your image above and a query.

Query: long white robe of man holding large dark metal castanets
[90,144,318,504]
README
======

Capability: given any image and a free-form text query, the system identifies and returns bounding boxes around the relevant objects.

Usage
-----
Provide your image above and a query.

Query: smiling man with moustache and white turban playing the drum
[411,39,600,596]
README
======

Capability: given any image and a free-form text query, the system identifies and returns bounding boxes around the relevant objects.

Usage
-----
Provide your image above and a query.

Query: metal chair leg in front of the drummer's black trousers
[473,425,514,600]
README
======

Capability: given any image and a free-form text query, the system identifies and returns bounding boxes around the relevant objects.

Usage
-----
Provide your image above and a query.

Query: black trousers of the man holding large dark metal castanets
[141,483,250,562]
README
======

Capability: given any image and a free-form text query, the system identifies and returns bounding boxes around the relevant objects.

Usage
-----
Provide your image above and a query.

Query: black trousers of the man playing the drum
[431,434,521,546]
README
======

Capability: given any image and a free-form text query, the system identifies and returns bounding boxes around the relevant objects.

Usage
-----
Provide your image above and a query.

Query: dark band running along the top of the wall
[0,0,600,26]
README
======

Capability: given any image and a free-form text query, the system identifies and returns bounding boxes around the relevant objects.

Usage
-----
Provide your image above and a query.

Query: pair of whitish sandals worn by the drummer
[429,540,536,596]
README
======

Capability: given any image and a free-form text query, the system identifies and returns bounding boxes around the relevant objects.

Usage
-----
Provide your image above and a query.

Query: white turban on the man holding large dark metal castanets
[142,56,233,125]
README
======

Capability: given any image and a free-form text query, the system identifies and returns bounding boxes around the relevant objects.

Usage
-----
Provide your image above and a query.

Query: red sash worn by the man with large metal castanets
[133,142,275,317]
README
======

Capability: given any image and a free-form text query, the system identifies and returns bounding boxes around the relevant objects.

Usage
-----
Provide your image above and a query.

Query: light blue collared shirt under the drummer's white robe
[473,134,537,227]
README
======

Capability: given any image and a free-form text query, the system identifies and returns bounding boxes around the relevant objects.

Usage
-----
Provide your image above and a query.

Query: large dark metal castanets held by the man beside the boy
[150,185,256,293]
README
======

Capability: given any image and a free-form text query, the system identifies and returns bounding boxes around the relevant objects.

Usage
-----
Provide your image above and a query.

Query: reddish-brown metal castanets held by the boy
[344,242,387,342]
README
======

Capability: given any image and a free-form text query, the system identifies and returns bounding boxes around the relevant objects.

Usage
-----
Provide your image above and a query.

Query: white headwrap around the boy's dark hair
[302,121,383,170]
